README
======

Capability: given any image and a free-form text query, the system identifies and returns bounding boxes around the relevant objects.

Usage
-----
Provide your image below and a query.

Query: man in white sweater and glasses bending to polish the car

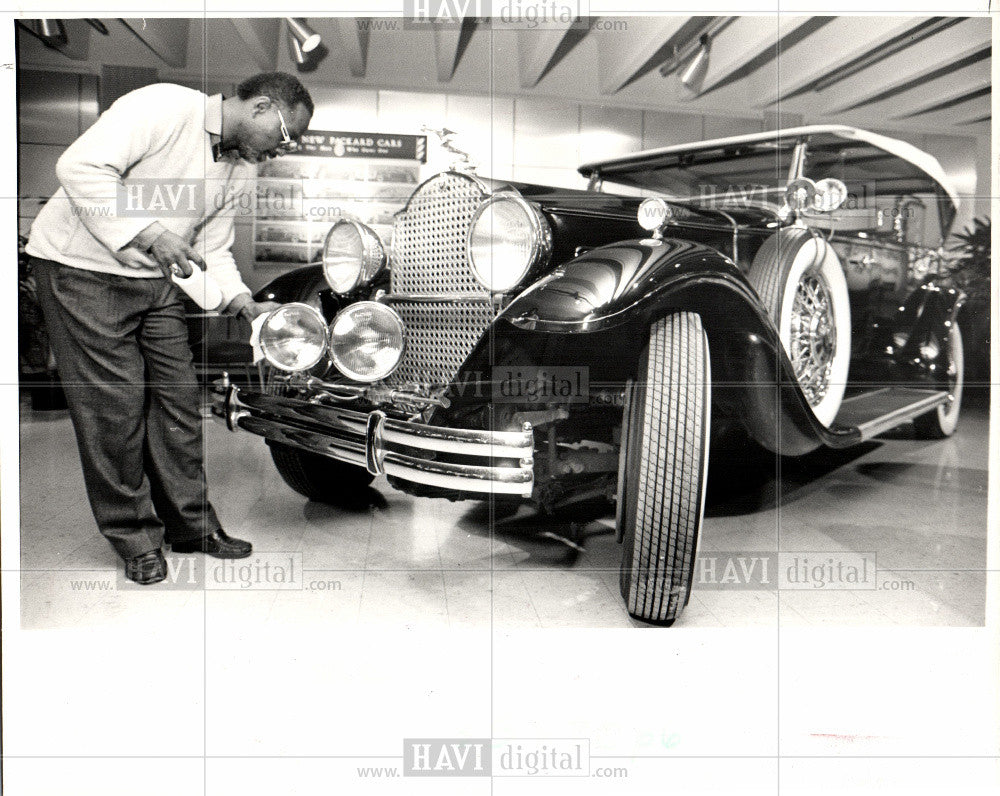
[26,72,313,584]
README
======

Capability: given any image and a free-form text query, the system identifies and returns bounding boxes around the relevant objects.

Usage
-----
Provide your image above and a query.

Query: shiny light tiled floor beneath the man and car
[21,391,988,628]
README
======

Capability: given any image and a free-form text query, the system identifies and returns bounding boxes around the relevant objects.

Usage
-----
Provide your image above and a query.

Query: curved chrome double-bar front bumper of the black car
[216,384,534,497]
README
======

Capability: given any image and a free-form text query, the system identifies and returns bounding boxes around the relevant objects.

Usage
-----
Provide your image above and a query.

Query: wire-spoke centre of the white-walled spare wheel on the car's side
[789,271,837,406]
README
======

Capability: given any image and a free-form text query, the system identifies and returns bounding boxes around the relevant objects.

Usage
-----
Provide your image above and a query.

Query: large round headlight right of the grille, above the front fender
[466,192,552,292]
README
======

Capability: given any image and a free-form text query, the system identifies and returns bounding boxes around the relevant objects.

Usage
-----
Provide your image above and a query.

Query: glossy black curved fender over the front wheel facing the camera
[450,240,860,455]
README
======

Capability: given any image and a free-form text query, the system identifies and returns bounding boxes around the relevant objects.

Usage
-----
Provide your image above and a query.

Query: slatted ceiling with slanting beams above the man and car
[18,14,992,135]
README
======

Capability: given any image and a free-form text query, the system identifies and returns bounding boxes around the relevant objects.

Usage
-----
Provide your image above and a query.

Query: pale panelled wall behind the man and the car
[20,67,990,289]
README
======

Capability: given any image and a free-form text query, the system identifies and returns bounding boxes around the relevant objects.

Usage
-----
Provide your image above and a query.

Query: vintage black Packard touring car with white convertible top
[219,126,963,625]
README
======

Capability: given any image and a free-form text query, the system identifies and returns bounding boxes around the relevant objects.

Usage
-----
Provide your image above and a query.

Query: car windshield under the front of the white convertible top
[601,139,796,206]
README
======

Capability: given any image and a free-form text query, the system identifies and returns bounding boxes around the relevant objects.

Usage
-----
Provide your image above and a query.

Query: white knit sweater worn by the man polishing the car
[26,83,257,305]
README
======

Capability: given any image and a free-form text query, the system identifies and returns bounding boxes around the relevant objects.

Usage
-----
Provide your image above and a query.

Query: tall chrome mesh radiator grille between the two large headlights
[386,173,496,395]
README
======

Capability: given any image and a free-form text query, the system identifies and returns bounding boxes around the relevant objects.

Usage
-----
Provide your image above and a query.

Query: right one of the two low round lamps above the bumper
[330,301,406,382]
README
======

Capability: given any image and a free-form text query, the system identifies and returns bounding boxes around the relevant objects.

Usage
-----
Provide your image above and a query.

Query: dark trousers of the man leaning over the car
[32,257,220,558]
